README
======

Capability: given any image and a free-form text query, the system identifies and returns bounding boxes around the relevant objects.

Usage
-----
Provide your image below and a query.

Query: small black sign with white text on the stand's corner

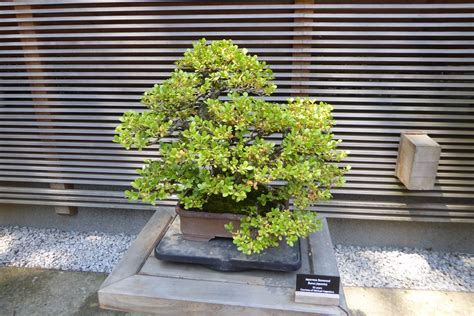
[296,274,341,294]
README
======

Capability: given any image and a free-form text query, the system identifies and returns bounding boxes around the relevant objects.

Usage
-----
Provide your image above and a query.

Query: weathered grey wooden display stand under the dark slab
[98,208,347,315]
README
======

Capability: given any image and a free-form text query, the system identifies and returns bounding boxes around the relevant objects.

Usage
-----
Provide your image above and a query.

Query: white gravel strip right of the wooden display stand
[335,245,474,292]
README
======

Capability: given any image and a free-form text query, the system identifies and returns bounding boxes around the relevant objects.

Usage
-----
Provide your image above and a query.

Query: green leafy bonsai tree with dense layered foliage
[115,39,348,254]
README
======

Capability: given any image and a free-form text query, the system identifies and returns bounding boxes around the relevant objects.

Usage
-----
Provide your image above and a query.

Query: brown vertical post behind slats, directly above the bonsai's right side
[292,0,314,96]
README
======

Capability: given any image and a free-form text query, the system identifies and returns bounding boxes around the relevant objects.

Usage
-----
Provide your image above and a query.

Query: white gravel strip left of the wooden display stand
[0,226,136,273]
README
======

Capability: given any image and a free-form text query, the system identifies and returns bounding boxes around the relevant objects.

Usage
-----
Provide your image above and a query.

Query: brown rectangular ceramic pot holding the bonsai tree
[176,204,242,241]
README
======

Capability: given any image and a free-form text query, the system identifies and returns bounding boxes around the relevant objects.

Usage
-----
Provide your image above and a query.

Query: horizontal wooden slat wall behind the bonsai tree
[0,0,474,222]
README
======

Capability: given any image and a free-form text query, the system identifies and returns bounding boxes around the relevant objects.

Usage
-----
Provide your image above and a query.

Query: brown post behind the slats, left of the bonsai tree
[15,0,77,215]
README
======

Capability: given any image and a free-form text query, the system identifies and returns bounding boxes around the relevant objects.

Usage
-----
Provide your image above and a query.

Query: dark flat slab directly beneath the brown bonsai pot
[155,218,301,271]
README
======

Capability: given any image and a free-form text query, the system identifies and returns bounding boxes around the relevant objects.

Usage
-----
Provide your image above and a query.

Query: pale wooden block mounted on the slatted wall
[395,133,441,190]
